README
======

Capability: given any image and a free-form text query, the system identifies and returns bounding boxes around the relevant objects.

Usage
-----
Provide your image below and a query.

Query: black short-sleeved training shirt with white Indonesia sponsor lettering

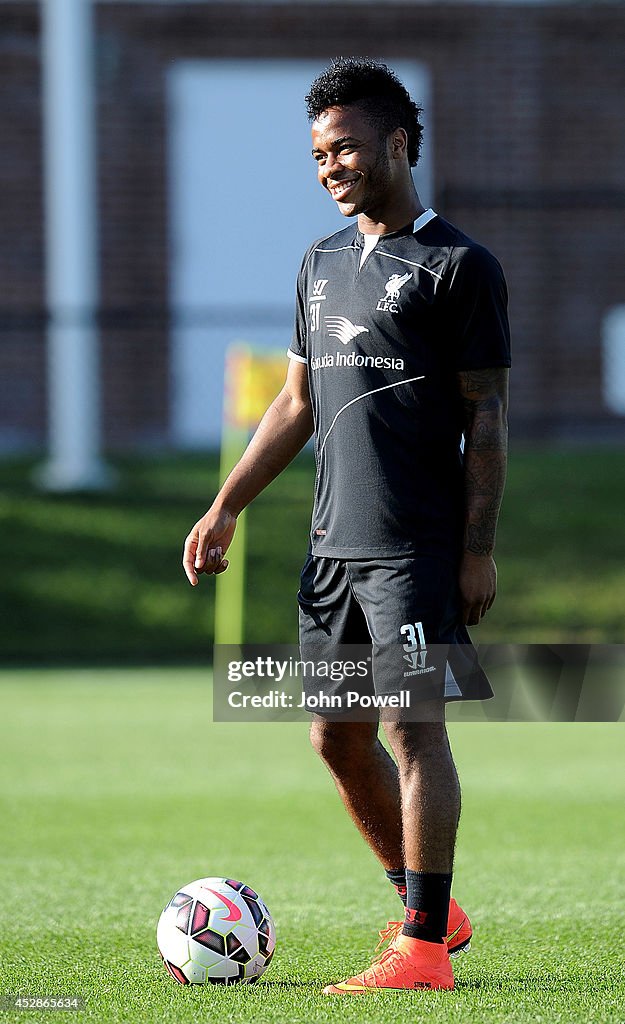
[289,210,510,559]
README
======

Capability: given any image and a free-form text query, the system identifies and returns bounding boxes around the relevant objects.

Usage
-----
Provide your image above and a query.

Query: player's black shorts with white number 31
[297,555,493,717]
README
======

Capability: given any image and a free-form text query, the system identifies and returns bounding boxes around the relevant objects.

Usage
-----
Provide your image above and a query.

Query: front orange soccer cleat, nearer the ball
[324,935,454,995]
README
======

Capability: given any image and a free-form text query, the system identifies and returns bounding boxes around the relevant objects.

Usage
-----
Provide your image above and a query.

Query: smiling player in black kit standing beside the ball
[184,59,509,994]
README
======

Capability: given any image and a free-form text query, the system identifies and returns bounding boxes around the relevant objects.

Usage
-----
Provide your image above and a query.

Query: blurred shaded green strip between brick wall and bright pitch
[0,450,625,664]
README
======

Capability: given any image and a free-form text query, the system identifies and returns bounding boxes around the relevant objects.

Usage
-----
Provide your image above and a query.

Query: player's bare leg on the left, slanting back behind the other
[310,716,404,869]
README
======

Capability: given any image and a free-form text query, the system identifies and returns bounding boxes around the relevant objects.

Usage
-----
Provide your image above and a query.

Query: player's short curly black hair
[306,57,423,167]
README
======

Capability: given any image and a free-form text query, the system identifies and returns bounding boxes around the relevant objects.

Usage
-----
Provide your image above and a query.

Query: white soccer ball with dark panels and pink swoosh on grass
[157,878,276,985]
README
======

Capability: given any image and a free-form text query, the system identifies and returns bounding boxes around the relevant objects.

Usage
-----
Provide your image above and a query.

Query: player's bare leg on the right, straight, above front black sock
[384,701,460,873]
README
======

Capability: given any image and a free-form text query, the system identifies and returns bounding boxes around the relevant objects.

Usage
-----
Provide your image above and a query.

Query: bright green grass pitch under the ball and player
[0,669,625,1024]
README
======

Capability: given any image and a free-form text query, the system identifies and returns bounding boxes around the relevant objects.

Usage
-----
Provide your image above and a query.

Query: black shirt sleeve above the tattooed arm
[446,245,510,370]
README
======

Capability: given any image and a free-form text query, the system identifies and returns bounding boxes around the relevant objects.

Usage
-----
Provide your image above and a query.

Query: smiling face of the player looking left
[313,105,393,221]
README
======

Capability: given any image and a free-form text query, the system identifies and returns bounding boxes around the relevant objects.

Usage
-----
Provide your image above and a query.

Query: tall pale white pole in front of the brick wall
[38,0,110,490]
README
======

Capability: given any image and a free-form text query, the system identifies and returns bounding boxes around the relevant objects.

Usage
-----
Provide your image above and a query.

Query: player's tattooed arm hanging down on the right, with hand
[458,370,508,626]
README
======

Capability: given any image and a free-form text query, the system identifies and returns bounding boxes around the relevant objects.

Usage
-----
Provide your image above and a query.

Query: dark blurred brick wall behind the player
[0,0,625,446]
